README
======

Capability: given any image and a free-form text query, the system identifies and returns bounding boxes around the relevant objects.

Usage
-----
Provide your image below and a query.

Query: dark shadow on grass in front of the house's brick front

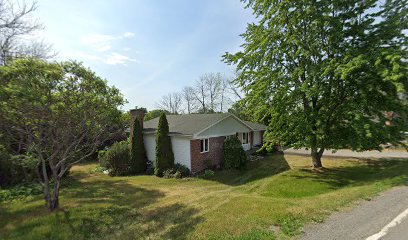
[210,153,290,186]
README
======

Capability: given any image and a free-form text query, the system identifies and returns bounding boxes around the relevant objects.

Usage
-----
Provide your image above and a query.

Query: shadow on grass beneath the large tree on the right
[294,159,408,189]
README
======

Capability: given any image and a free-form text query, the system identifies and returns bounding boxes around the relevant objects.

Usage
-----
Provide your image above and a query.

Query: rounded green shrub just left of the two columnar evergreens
[99,141,130,176]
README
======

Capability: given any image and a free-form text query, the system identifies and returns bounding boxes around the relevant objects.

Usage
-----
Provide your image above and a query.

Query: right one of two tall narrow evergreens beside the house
[155,113,174,176]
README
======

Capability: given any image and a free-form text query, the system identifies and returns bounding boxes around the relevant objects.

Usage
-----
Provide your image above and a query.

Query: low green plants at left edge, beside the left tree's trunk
[0,183,42,202]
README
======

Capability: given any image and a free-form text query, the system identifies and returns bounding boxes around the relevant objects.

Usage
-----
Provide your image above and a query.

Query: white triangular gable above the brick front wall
[196,117,251,138]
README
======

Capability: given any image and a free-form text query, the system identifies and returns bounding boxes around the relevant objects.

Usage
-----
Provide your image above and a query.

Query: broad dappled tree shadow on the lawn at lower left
[0,174,203,239]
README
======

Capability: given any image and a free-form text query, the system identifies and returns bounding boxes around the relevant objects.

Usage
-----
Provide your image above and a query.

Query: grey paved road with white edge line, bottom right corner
[301,187,408,240]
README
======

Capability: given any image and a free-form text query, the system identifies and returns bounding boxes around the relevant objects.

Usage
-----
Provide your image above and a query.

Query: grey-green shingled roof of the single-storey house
[143,113,266,135]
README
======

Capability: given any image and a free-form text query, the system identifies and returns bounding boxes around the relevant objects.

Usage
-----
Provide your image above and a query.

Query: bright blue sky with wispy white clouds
[35,0,253,110]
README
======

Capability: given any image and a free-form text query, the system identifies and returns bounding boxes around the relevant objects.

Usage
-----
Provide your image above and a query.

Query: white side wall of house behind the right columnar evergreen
[143,134,191,170]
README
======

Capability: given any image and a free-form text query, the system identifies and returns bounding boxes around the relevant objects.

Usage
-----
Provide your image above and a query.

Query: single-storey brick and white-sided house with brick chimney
[130,109,266,173]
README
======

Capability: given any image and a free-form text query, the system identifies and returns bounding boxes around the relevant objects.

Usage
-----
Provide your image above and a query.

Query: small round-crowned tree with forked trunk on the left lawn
[0,60,124,210]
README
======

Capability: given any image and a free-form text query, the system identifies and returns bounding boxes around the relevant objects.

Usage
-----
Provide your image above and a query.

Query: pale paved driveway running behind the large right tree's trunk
[284,148,408,158]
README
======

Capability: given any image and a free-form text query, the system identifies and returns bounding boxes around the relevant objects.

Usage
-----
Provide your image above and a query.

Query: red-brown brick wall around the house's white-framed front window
[190,137,225,173]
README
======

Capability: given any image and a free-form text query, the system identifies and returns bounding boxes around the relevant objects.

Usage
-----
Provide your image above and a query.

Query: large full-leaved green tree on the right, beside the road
[224,0,408,167]
